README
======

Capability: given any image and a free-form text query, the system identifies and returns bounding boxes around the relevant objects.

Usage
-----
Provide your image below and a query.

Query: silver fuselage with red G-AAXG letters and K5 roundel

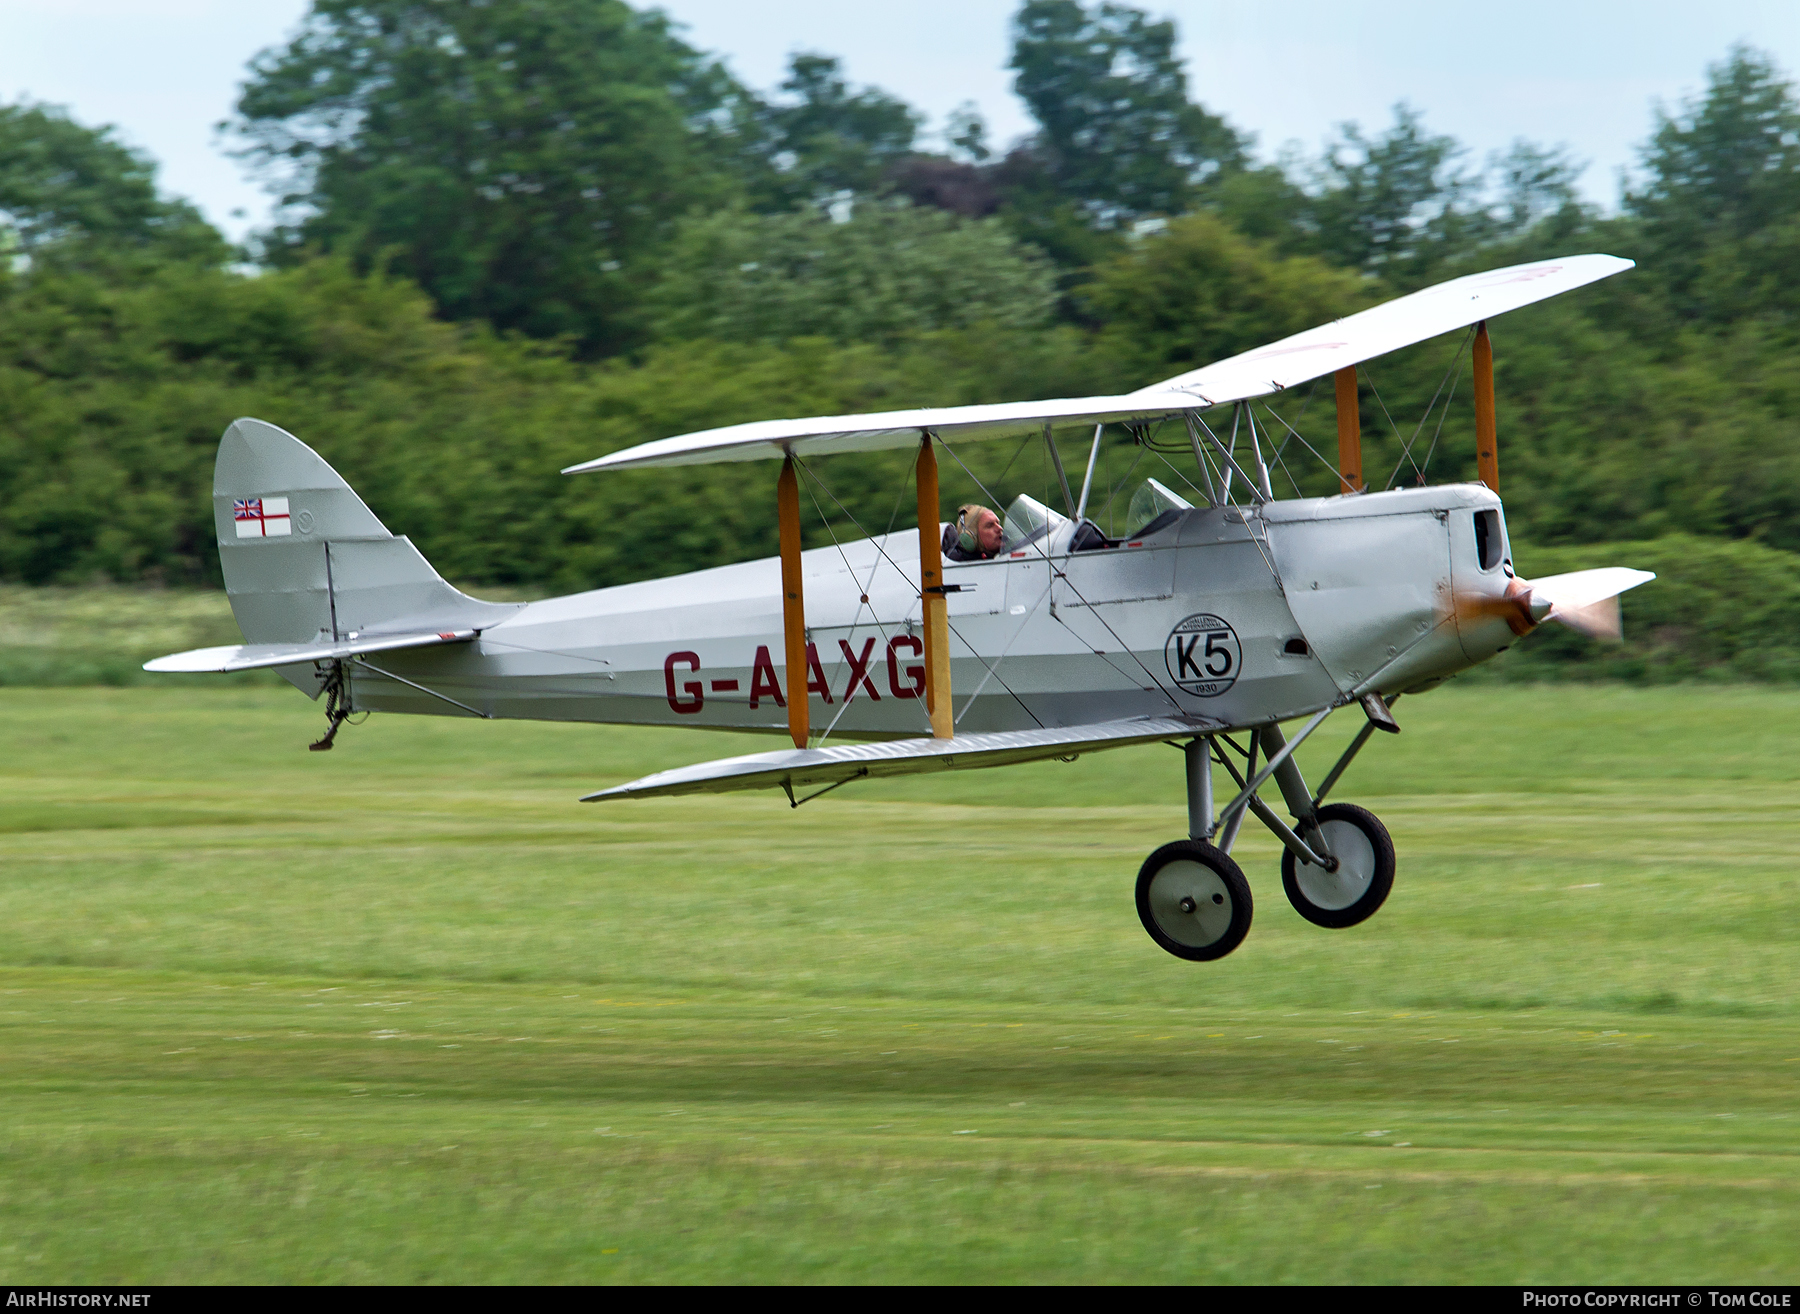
[343,484,1514,738]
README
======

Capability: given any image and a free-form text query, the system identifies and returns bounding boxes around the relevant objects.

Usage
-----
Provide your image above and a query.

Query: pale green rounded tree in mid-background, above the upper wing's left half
[648,202,1057,344]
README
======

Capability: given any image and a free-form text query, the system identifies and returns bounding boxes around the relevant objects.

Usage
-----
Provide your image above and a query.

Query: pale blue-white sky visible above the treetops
[0,0,1800,238]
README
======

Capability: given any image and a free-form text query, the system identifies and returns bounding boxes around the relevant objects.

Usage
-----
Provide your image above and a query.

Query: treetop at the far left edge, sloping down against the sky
[0,103,225,263]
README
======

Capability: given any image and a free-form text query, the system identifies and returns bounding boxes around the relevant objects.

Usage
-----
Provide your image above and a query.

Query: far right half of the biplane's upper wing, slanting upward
[1132,256,1634,405]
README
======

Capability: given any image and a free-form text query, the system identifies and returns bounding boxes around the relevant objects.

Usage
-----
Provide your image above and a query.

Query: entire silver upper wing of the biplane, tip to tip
[563,256,1633,475]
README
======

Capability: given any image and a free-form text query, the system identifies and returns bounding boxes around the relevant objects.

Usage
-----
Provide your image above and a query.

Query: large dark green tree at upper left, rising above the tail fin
[238,0,749,351]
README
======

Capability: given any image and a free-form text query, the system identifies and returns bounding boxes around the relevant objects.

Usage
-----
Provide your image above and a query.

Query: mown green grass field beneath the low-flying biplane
[0,686,1800,1283]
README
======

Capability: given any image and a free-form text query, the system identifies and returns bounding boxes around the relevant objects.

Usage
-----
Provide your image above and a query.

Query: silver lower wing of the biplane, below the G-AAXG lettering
[581,716,1224,803]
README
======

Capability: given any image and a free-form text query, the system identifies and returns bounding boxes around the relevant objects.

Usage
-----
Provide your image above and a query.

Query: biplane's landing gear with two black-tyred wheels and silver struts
[1138,695,1400,961]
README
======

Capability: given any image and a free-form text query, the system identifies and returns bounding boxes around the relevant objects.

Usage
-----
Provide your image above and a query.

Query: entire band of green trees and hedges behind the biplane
[0,0,1800,676]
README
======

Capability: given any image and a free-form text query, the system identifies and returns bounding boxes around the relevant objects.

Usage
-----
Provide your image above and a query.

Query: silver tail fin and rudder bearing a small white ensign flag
[212,419,518,695]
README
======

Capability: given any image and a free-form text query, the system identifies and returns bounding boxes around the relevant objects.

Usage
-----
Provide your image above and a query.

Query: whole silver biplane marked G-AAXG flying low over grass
[146,256,1654,961]
